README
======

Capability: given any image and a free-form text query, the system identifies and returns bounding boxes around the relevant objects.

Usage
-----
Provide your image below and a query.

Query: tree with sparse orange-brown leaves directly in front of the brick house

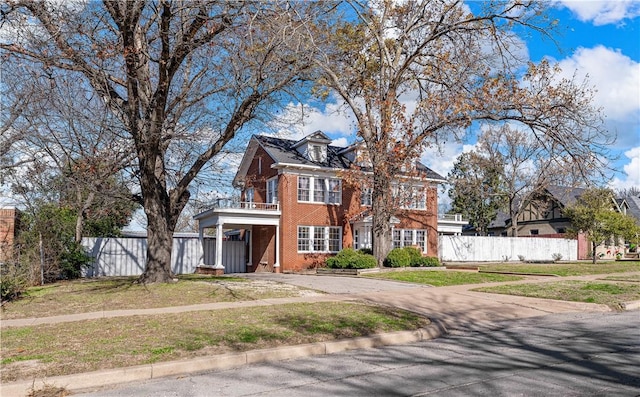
[316,0,607,264]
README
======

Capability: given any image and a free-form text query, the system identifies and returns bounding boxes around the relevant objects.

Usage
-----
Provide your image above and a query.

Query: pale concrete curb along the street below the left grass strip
[0,320,447,397]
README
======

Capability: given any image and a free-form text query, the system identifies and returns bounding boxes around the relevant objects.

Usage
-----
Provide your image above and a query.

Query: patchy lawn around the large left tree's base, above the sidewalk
[2,275,320,319]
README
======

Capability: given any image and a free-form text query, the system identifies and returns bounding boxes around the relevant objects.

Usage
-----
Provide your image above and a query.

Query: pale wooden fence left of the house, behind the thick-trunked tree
[82,234,246,277]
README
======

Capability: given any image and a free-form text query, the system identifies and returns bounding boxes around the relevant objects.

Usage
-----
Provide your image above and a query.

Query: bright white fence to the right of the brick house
[438,236,578,262]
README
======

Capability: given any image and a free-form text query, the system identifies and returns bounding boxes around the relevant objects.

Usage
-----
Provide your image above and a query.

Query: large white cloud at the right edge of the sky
[558,46,640,148]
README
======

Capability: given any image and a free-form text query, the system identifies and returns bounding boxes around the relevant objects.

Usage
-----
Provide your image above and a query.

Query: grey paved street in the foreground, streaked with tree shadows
[80,311,640,397]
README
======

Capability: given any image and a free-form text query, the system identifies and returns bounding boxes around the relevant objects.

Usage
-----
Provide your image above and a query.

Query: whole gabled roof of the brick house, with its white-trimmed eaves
[234,131,445,185]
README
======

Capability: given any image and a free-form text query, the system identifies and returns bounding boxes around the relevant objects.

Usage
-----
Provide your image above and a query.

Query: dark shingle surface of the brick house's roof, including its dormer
[254,135,446,181]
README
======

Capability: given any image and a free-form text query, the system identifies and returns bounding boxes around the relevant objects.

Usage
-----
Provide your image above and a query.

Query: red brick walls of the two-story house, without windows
[235,133,438,272]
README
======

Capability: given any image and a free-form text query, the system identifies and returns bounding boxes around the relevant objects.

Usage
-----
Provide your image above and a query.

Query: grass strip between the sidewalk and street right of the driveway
[474,280,640,310]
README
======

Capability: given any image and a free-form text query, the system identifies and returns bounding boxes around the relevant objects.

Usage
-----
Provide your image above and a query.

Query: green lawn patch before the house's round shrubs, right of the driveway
[365,270,523,287]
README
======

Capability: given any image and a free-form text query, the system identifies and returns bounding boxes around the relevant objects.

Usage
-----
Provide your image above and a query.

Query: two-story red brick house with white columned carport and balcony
[194,131,448,272]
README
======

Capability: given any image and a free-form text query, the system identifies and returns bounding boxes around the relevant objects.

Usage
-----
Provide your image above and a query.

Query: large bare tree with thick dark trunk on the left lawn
[0,0,324,283]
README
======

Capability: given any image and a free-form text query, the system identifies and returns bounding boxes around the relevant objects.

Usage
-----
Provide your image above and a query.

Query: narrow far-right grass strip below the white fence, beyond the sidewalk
[480,261,640,276]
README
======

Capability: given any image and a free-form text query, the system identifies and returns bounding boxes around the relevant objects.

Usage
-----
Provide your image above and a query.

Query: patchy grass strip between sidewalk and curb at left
[0,303,429,382]
